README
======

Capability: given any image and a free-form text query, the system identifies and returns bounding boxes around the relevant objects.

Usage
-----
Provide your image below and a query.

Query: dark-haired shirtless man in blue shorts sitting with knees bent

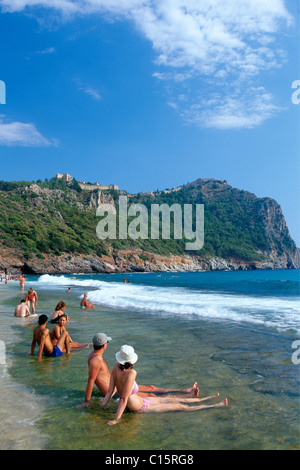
[31,315,70,361]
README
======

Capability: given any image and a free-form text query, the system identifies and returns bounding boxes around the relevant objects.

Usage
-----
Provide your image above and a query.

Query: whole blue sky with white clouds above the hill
[0,0,300,246]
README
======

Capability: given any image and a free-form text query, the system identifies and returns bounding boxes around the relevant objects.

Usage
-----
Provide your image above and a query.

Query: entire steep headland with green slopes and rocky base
[0,179,300,274]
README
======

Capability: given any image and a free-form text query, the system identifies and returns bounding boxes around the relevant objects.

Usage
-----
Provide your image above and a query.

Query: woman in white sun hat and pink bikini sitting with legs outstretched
[102,345,228,425]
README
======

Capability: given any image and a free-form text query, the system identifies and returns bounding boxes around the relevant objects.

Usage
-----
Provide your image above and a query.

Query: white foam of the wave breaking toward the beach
[38,275,300,332]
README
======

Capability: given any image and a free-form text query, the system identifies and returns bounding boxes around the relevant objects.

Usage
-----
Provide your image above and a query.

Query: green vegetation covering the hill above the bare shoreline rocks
[0,178,295,261]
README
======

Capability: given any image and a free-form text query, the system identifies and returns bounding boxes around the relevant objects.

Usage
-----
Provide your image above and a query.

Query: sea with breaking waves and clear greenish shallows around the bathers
[0,270,300,452]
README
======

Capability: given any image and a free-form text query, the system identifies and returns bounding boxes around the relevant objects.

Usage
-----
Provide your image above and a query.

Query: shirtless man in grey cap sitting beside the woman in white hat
[77,333,199,408]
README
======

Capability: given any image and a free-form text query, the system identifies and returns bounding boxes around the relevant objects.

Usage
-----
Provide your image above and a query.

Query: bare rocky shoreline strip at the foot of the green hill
[0,244,300,275]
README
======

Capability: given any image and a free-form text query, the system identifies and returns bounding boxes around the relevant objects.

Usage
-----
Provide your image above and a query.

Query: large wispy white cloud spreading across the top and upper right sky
[0,0,293,128]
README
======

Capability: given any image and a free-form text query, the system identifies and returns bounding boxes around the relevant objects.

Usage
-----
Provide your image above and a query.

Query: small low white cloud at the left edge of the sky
[0,115,57,147]
